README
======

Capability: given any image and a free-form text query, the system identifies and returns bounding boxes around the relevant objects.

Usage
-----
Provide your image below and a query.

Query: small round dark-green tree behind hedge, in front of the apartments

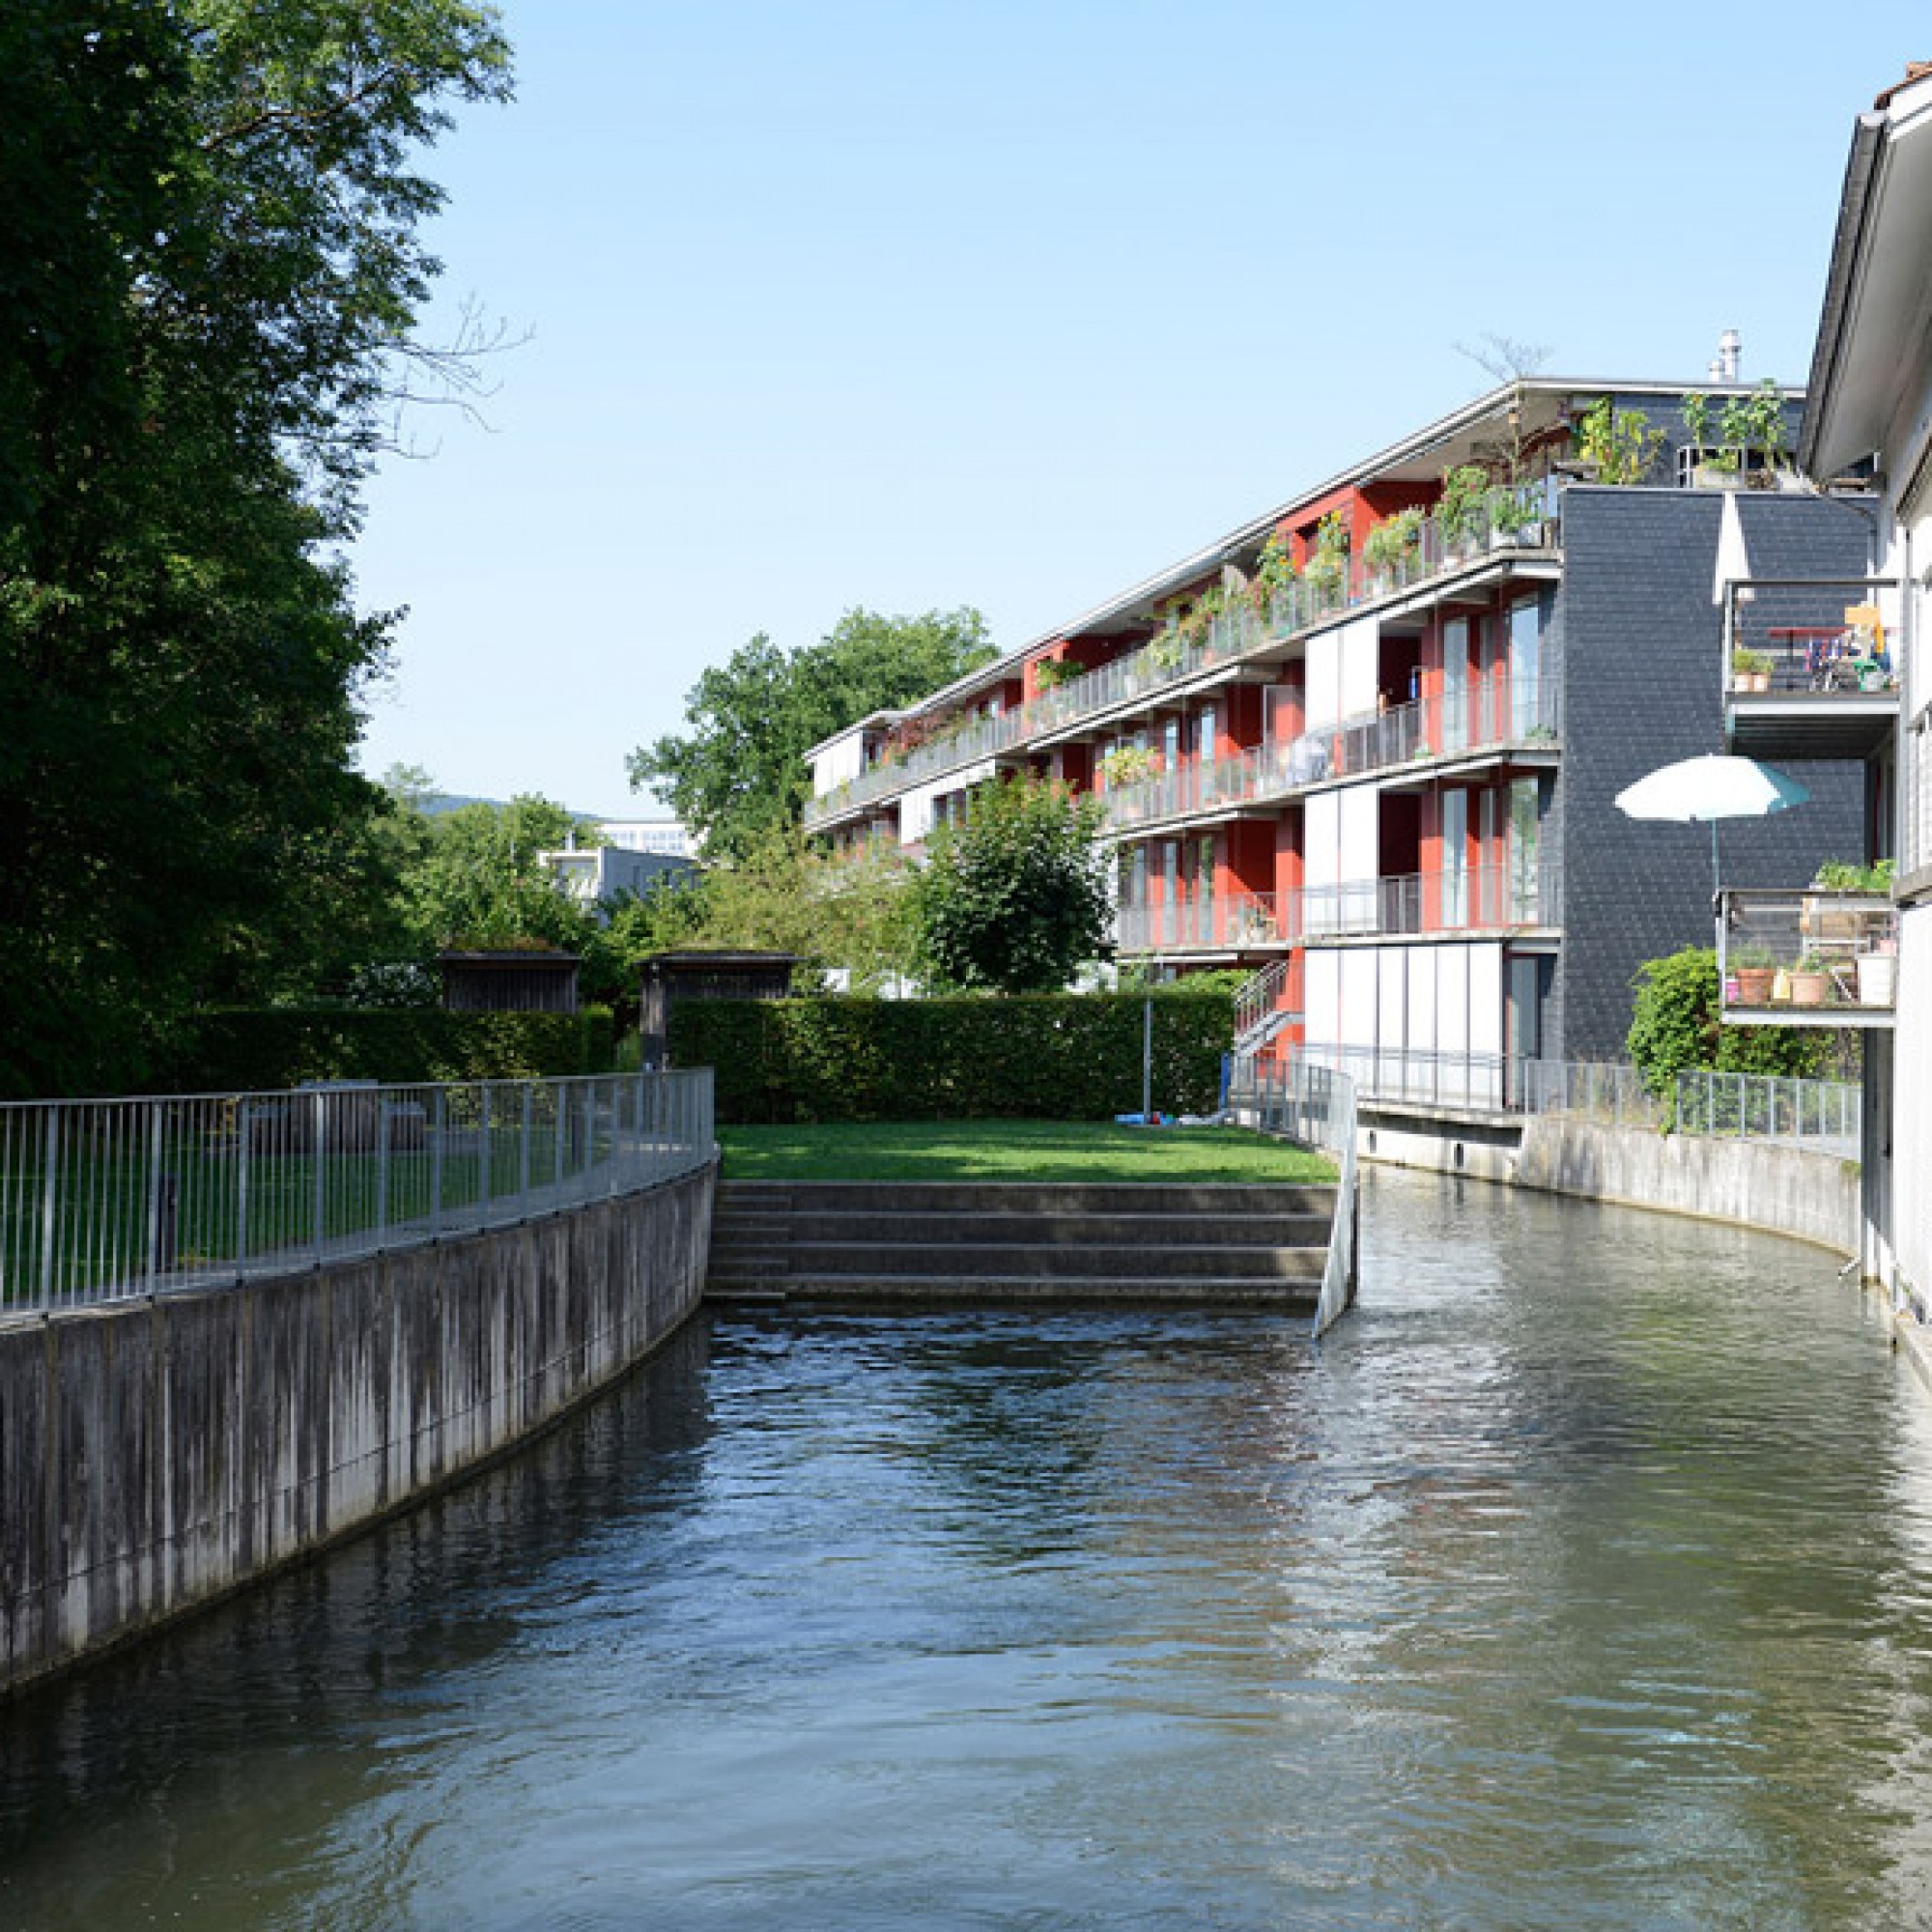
[912,779,1113,993]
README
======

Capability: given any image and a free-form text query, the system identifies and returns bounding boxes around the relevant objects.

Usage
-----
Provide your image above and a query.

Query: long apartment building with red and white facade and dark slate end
[806,379,1866,1103]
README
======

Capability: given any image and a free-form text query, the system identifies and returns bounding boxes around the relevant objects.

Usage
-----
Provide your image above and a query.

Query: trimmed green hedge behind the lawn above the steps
[668,993,1235,1122]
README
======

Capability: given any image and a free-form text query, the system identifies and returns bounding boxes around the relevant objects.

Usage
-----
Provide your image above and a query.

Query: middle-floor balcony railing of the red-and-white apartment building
[1101,678,1557,831]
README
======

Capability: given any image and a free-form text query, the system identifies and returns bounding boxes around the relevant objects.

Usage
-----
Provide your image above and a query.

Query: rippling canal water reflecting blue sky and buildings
[0,1173,1932,1932]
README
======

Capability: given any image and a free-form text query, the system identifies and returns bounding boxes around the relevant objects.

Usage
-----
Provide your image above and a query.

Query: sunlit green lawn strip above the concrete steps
[719,1121,1335,1180]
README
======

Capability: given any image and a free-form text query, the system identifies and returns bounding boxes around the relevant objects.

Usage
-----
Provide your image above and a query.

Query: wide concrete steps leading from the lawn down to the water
[705,1180,1335,1308]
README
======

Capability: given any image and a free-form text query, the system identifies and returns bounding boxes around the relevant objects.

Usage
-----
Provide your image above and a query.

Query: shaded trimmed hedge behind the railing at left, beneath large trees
[166,1007,614,1094]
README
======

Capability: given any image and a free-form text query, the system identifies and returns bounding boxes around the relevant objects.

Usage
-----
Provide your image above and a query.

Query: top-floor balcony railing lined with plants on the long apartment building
[806,483,1561,831]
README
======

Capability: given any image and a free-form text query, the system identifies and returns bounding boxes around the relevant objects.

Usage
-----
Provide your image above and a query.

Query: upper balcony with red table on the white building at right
[1723,578,1899,759]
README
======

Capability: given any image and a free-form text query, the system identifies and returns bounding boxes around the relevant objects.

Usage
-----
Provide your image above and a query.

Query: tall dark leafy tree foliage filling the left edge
[0,0,506,1092]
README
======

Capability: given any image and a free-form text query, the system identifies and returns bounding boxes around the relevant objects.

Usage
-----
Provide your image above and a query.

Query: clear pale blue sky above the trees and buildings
[354,0,1932,815]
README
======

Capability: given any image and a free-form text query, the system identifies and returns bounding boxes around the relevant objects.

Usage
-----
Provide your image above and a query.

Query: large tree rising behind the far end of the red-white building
[630,609,995,856]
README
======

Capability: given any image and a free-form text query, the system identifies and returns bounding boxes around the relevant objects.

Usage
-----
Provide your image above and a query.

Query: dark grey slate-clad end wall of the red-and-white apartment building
[1546,487,1868,1059]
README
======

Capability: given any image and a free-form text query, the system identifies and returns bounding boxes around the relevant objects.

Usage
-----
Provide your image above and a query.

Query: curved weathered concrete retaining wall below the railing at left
[0,1167,715,1689]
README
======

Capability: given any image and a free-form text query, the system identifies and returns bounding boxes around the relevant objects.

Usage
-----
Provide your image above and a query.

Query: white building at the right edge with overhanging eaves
[1770,62,1932,1323]
